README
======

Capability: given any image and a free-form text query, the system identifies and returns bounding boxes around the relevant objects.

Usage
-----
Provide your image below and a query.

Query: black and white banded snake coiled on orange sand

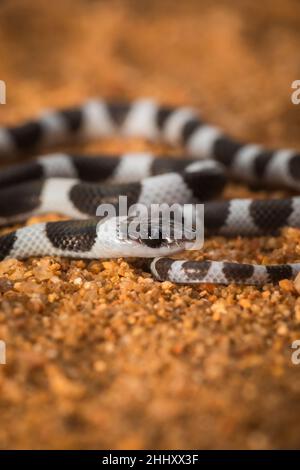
[0,98,300,286]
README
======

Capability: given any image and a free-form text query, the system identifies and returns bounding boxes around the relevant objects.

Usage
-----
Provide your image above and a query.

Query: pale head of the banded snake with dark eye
[97,216,199,258]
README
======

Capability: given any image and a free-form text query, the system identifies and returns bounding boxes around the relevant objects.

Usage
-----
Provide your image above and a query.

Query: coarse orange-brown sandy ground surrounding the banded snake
[0,0,300,449]
